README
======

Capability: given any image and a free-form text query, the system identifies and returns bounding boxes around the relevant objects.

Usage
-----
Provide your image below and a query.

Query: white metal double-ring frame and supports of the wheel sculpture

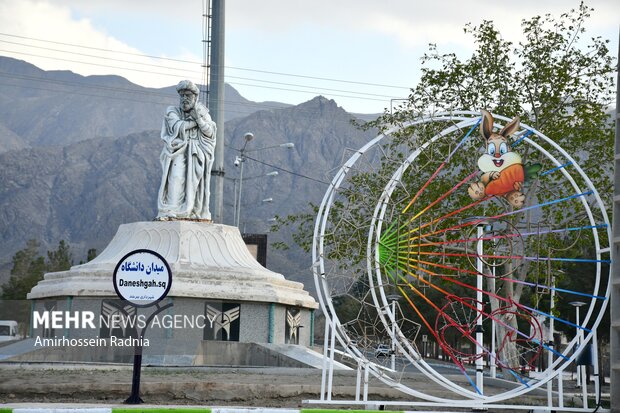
[305,111,611,411]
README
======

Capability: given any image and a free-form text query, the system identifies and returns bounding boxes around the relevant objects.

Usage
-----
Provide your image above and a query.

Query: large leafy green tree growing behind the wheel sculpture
[282,3,615,372]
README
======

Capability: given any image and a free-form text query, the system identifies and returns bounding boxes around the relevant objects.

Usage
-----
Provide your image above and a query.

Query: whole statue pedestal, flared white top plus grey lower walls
[28,221,318,364]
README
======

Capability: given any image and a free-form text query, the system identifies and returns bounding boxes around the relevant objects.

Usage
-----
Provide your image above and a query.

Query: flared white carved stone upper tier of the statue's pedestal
[28,220,318,309]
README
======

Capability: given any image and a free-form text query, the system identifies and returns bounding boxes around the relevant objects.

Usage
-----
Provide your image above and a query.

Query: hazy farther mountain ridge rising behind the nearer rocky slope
[0,56,287,152]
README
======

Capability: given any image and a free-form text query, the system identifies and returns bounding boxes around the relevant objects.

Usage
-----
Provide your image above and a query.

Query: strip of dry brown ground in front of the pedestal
[0,363,600,410]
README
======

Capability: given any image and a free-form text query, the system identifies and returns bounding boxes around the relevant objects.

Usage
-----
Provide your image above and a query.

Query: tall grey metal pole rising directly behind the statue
[205,0,226,224]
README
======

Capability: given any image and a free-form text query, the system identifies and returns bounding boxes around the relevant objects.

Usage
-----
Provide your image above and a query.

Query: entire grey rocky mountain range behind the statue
[0,57,375,287]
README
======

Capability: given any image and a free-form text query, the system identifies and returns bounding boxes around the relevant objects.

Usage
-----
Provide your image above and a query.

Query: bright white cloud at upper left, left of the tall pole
[0,0,195,86]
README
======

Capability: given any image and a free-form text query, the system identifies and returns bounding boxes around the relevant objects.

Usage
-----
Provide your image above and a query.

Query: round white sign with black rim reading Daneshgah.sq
[112,249,172,307]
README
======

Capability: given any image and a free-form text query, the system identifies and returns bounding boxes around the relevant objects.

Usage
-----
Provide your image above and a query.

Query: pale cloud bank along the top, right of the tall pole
[227,0,620,47]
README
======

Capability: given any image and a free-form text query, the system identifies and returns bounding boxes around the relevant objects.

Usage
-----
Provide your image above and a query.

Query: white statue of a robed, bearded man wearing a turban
[157,80,216,220]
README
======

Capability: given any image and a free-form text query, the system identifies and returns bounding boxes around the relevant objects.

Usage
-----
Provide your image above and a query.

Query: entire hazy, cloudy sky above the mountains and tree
[0,0,620,113]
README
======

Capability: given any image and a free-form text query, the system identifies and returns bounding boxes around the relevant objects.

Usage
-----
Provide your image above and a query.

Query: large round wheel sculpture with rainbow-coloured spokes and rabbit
[313,111,611,405]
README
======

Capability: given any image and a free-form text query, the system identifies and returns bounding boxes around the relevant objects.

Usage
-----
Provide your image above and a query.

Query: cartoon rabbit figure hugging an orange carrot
[468,110,525,208]
